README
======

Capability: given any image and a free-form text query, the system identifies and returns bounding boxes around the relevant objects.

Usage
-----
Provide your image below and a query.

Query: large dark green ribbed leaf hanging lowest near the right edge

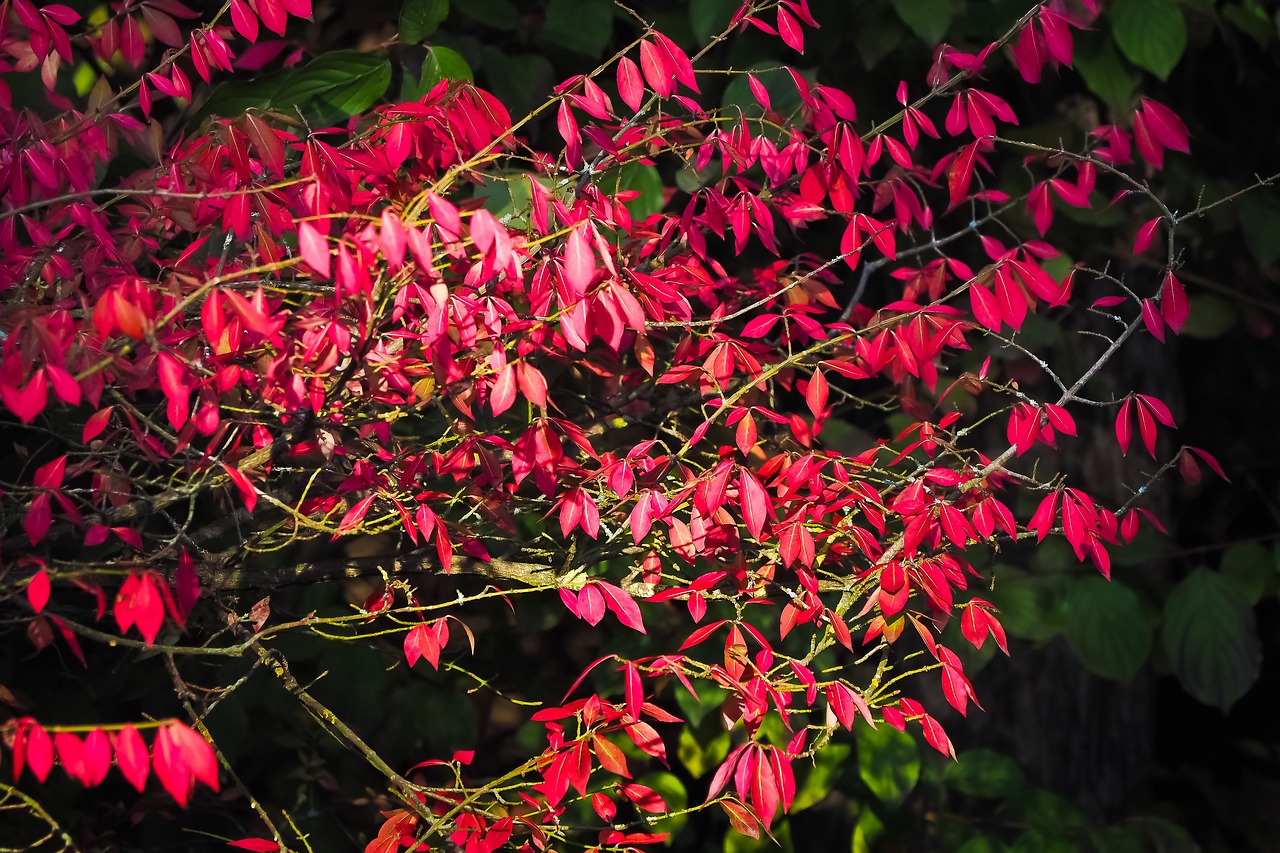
[1161,567,1262,711]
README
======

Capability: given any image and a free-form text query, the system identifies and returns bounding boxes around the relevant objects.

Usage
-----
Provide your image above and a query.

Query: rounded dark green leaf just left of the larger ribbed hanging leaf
[1064,576,1155,681]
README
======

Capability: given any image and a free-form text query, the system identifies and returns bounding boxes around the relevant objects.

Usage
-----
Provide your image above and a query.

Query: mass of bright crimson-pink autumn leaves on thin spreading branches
[0,0,1239,853]
